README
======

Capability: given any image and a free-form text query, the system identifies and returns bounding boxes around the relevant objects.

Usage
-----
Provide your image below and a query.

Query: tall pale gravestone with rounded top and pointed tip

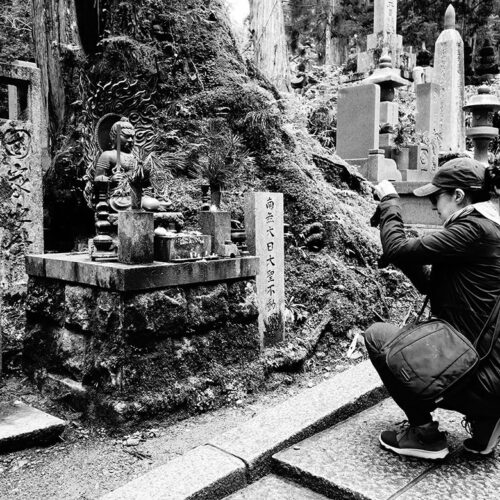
[433,4,465,153]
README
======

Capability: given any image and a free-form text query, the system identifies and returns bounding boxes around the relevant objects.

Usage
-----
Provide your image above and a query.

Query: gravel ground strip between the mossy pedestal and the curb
[0,339,362,500]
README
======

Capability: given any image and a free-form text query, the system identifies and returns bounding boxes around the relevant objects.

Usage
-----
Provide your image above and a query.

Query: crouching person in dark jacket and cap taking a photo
[365,158,500,459]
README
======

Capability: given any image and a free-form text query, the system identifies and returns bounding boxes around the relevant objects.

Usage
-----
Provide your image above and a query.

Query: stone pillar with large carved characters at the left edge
[0,61,43,376]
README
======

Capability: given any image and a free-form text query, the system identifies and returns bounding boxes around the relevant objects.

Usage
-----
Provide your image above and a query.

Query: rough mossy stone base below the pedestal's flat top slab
[23,277,263,421]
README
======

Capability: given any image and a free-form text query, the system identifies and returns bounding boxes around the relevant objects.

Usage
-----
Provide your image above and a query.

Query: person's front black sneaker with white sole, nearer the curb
[379,422,449,460]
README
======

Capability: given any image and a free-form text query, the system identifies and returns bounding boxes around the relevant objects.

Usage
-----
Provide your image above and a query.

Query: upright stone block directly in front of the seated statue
[118,210,154,264]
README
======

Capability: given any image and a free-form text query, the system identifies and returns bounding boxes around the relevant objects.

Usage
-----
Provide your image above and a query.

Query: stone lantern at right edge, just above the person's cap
[464,85,500,165]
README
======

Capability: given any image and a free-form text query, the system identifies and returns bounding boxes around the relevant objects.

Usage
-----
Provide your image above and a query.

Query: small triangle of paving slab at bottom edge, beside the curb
[226,474,327,500]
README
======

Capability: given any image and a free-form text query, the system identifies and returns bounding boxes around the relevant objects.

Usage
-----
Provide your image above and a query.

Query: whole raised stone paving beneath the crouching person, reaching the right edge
[273,399,500,500]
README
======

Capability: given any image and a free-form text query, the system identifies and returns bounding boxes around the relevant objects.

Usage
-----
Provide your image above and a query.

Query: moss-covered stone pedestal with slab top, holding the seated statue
[23,253,262,425]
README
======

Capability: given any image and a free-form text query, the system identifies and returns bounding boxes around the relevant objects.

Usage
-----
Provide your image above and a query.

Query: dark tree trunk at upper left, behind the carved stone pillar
[32,0,76,146]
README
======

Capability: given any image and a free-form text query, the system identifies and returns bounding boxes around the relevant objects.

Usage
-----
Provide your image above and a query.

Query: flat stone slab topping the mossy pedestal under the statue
[26,253,259,292]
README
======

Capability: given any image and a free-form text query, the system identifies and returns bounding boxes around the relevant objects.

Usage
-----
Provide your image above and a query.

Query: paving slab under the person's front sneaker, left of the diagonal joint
[274,399,472,500]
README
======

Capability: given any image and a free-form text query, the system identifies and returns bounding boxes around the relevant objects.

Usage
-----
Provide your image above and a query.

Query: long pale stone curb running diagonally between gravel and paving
[102,361,386,500]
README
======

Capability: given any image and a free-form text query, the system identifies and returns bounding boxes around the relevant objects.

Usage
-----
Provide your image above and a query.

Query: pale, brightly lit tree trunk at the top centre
[250,0,290,91]
